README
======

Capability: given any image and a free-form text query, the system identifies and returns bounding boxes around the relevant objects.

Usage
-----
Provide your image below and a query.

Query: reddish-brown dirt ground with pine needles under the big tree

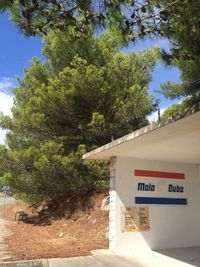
[0,195,108,261]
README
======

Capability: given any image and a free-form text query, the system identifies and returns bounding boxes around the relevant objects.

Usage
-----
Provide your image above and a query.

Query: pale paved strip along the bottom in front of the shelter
[0,254,195,267]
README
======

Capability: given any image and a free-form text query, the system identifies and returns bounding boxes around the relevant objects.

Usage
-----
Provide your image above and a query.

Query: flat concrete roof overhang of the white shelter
[83,111,200,164]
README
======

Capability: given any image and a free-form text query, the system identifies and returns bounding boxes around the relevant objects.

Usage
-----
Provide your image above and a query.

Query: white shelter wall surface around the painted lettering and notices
[109,157,200,254]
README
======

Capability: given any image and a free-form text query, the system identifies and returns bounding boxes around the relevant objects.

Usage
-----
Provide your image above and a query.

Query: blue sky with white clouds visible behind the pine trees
[0,14,179,143]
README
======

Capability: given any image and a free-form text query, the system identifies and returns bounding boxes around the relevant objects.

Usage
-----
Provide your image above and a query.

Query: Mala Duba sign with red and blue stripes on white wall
[134,169,187,205]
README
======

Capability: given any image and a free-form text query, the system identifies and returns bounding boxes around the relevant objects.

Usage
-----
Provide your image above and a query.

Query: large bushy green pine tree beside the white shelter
[0,31,158,201]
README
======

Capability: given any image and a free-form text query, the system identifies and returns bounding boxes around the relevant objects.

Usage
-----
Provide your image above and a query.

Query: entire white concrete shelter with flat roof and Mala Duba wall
[84,112,200,255]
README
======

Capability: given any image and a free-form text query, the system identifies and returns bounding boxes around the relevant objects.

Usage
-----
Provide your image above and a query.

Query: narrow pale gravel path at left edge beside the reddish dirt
[0,205,10,262]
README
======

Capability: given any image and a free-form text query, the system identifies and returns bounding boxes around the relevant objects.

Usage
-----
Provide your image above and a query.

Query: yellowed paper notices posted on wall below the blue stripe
[121,206,150,232]
